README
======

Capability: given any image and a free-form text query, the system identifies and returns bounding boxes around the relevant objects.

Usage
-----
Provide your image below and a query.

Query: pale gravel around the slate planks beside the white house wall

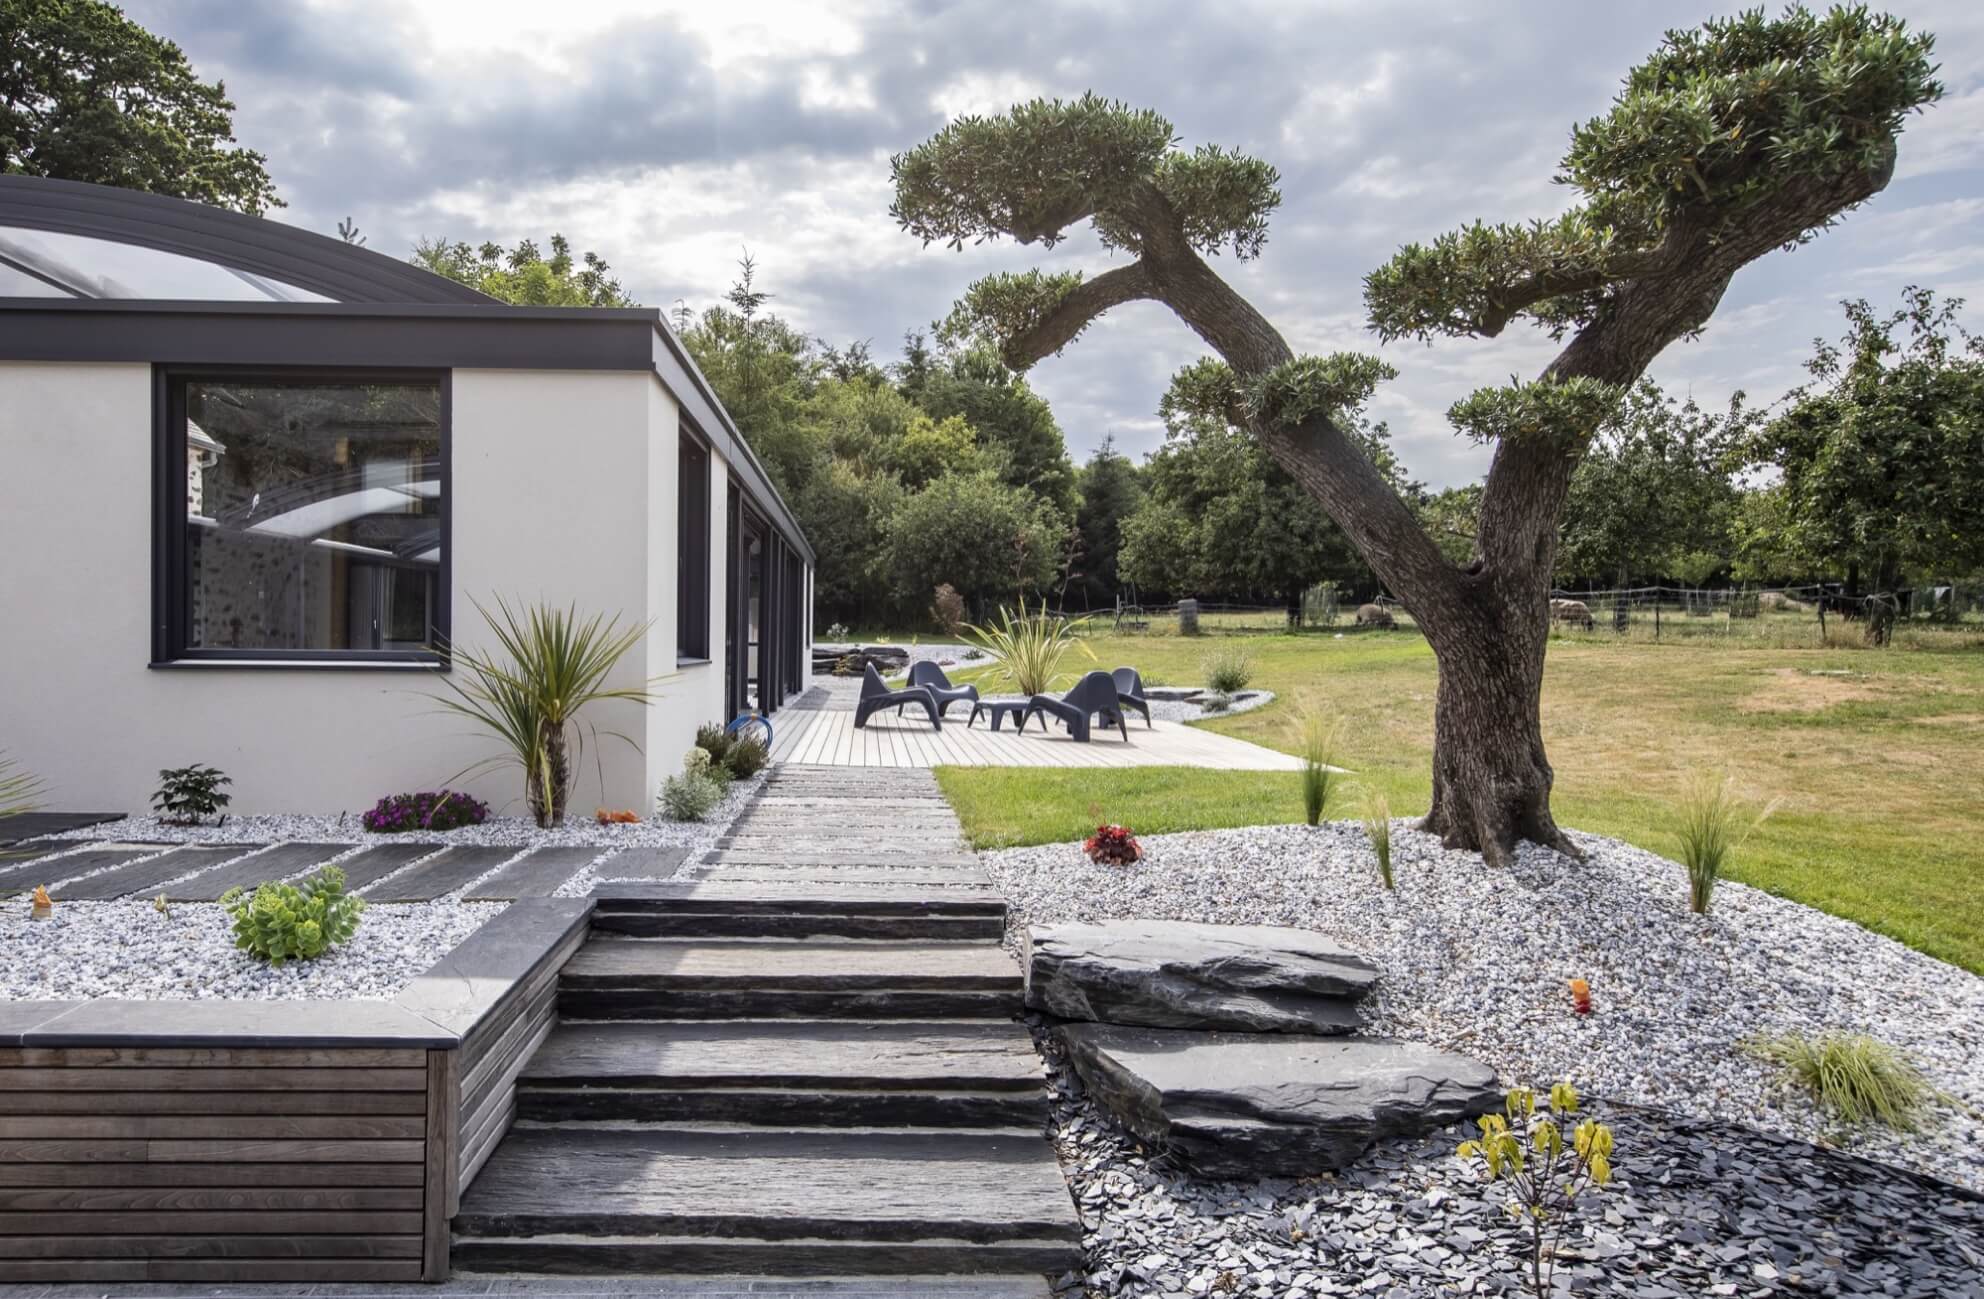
[0,773,764,1002]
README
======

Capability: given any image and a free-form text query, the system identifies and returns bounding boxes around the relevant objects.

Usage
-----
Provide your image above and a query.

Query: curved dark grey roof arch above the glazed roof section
[0,175,490,303]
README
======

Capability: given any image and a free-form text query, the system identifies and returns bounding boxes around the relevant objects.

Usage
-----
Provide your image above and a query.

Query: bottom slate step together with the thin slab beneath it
[454,1126,1081,1275]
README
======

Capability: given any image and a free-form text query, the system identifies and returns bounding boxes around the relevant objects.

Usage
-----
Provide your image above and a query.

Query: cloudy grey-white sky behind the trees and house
[127,0,1984,486]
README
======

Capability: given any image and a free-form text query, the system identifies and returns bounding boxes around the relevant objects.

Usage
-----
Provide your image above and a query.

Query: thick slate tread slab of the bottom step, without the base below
[454,1130,1081,1240]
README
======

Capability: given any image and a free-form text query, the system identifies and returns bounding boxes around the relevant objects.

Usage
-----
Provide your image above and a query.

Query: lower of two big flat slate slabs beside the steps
[1055,1023,1502,1178]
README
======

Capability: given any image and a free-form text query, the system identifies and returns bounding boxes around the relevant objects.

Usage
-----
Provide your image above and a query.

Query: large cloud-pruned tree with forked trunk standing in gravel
[893,8,1940,863]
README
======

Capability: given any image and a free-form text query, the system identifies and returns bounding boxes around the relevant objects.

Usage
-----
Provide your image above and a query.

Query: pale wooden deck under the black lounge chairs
[772,708,1302,771]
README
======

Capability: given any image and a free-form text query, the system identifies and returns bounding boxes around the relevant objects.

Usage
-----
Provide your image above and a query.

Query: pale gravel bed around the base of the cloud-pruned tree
[982,823,1984,1190]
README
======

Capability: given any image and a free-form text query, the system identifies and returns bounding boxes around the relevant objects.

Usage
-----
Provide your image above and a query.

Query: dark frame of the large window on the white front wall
[149,363,454,672]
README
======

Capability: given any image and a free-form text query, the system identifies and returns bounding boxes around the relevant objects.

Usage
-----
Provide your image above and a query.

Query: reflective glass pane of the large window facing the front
[185,381,444,650]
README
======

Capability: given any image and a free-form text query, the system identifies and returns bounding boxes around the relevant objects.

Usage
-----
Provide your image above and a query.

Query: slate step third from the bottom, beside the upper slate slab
[558,936,1022,1019]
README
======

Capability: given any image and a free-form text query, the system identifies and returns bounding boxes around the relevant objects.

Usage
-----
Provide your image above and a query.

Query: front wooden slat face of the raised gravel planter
[0,1047,438,1283]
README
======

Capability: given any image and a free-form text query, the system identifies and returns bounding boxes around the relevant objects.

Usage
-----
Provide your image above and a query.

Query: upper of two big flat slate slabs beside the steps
[1026,920,1379,1033]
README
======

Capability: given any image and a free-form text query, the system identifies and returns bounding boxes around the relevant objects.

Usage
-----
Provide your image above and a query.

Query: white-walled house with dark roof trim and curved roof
[0,177,813,815]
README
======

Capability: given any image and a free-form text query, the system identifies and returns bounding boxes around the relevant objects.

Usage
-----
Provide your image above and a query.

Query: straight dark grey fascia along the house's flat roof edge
[0,297,815,563]
